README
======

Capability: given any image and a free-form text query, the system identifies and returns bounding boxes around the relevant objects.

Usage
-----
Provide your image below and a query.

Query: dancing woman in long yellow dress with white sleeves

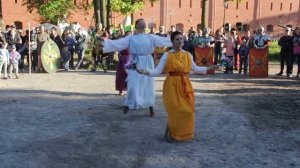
[137,31,217,142]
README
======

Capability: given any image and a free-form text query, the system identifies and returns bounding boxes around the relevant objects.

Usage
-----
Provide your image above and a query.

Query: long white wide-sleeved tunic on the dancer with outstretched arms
[103,34,172,109]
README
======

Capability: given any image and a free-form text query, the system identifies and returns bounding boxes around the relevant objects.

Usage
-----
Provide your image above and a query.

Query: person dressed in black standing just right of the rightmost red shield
[276,28,293,77]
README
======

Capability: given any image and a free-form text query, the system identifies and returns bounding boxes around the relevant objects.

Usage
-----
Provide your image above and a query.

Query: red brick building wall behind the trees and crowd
[2,0,300,36]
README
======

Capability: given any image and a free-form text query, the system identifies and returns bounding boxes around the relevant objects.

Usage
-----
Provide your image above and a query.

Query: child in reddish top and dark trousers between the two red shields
[224,36,235,74]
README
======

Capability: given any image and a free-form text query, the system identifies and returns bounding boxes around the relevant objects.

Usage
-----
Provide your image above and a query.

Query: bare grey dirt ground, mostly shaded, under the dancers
[0,65,300,168]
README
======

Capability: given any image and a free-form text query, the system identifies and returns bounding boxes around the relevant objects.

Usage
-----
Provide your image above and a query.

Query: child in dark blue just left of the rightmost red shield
[239,39,249,75]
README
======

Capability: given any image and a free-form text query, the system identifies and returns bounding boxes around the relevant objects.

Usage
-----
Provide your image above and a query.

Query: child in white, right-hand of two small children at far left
[8,45,21,79]
